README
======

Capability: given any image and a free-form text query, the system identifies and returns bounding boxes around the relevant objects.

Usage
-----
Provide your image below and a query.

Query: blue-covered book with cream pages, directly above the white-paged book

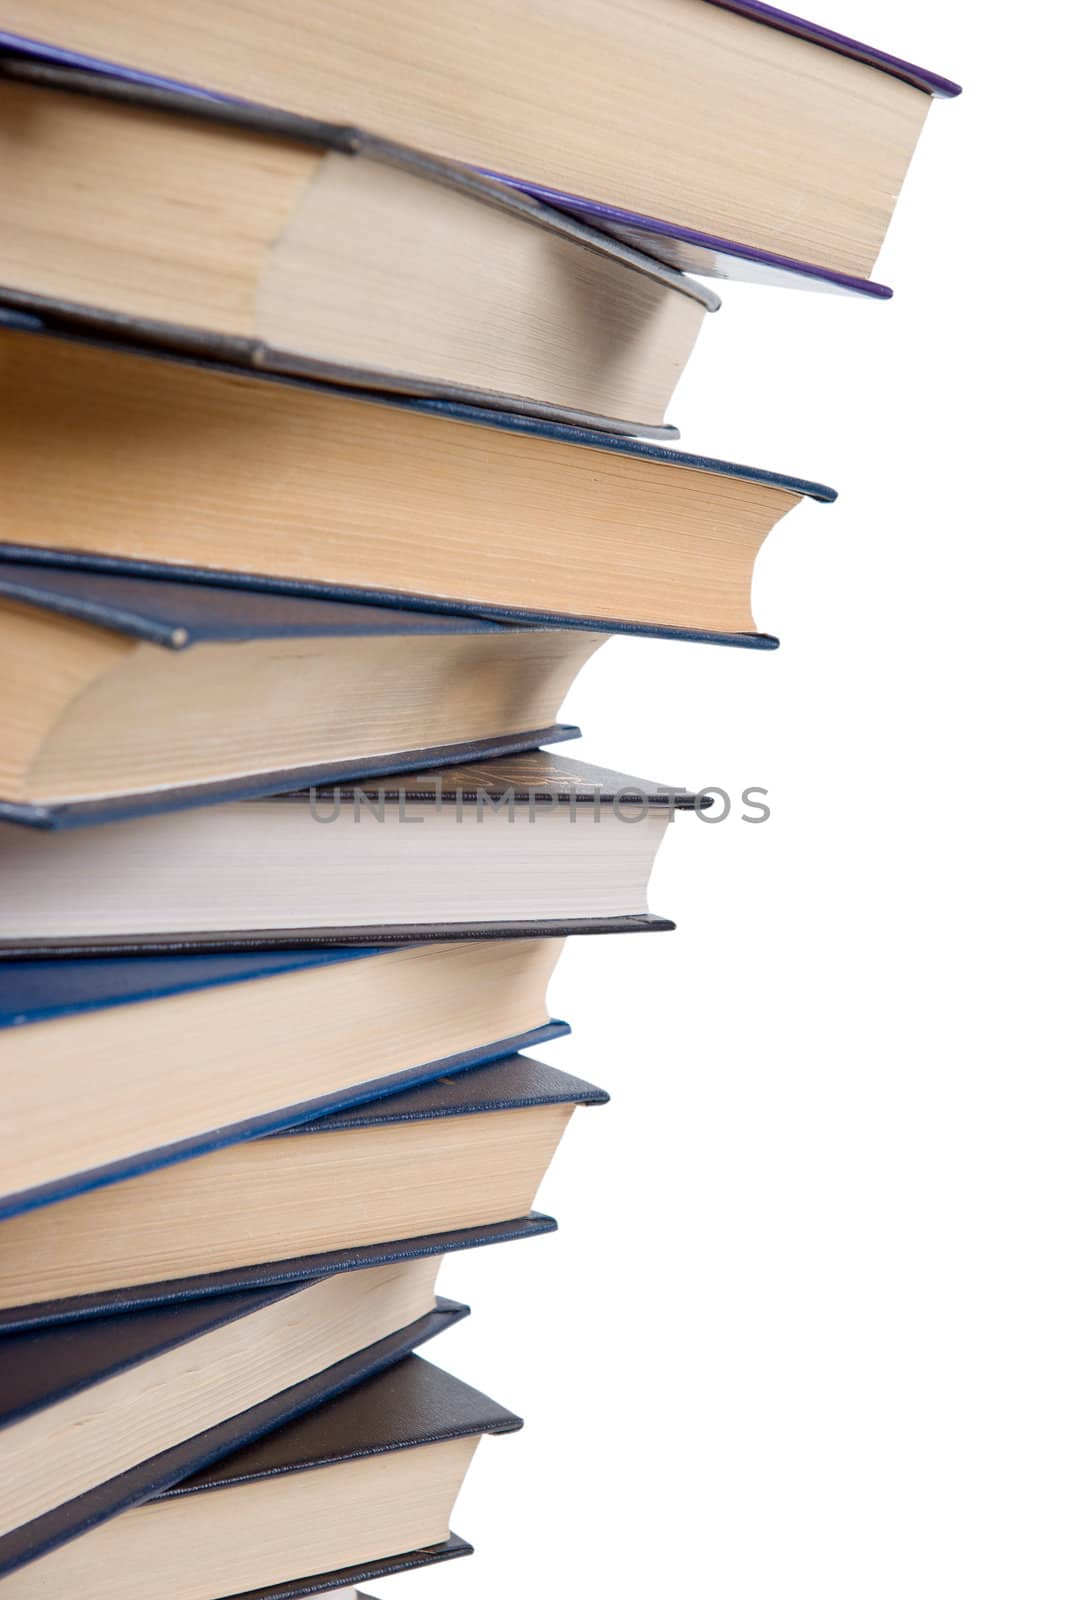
[0,558,605,827]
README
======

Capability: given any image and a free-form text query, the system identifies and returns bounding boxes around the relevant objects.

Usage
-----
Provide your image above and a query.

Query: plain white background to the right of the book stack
[373,0,1071,1600]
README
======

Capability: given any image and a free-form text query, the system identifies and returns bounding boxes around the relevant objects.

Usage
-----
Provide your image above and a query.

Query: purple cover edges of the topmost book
[0,0,961,299]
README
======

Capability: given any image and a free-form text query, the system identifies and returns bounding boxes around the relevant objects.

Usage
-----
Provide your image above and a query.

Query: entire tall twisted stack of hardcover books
[0,0,954,1600]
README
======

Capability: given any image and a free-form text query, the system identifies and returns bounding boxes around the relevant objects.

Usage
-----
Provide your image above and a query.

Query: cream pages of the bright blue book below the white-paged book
[0,934,562,1194]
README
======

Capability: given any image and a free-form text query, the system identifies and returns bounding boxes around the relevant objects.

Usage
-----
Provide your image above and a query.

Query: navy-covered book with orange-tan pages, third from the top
[0,310,836,648]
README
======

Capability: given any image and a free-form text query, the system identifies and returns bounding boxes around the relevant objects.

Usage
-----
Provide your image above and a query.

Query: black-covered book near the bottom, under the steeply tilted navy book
[3,1355,520,1600]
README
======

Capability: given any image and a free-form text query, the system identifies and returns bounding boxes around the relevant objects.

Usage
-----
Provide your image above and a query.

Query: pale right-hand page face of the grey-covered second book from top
[256,154,704,424]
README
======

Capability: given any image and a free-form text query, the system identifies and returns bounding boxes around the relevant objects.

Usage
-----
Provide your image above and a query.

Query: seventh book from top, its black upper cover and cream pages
[0,1056,608,1307]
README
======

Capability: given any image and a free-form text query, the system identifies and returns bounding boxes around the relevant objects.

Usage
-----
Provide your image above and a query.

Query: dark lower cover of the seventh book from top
[0,1211,557,1336]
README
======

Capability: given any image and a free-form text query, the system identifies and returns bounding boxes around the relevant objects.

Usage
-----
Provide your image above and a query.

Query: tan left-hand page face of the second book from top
[0,80,313,336]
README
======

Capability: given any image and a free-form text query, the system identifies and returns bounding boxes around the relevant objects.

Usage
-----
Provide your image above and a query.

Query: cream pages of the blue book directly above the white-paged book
[18,616,604,803]
